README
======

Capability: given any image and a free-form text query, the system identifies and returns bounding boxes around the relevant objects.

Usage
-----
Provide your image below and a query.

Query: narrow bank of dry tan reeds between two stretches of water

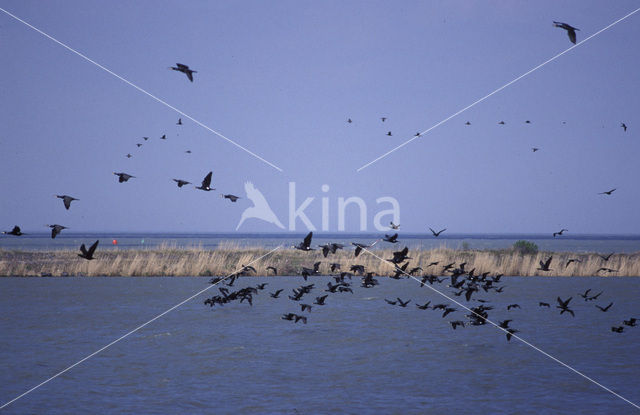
[0,245,640,277]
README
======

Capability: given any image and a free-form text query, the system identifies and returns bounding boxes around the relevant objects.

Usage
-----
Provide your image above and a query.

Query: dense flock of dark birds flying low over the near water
[204,231,637,341]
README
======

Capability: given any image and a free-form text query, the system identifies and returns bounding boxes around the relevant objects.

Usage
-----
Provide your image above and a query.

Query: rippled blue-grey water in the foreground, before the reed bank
[0,277,640,414]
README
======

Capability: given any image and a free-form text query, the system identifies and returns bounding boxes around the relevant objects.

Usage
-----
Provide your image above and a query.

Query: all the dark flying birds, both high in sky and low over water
[2,22,637,340]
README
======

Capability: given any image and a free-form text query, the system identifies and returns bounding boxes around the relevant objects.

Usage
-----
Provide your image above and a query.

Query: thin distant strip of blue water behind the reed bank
[0,230,640,254]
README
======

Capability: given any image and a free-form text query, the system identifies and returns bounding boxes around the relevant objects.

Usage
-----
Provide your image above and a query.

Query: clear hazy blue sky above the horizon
[0,0,640,234]
